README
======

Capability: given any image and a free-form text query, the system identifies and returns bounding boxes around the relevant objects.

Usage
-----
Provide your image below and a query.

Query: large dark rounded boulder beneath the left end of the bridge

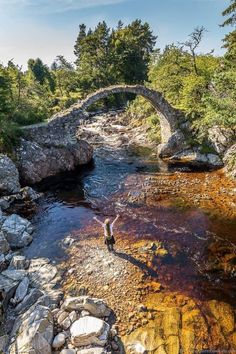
[17,139,93,184]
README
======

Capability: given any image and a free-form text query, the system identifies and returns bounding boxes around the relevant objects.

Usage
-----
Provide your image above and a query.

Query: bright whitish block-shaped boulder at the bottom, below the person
[70,316,110,347]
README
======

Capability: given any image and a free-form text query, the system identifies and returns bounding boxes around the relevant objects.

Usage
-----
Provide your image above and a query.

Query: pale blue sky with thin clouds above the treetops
[0,0,230,69]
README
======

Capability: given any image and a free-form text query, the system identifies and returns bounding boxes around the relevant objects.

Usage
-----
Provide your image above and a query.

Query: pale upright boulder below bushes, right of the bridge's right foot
[208,126,235,154]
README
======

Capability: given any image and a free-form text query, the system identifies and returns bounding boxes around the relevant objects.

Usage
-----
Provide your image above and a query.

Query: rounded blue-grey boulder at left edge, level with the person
[2,214,33,248]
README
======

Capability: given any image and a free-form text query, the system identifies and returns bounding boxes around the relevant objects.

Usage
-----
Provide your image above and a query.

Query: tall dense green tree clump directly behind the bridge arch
[74,20,156,93]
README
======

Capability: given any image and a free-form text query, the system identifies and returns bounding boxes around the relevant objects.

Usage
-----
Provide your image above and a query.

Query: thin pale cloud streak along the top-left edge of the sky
[0,0,129,13]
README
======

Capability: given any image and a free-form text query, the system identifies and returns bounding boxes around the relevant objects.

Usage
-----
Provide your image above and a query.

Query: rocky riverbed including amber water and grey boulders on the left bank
[0,112,236,354]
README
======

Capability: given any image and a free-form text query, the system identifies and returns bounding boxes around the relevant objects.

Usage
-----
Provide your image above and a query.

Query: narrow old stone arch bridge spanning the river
[48,85,186,143]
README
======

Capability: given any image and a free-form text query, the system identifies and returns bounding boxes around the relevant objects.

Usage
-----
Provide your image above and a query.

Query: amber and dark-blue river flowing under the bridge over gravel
[25,116,236,354]
